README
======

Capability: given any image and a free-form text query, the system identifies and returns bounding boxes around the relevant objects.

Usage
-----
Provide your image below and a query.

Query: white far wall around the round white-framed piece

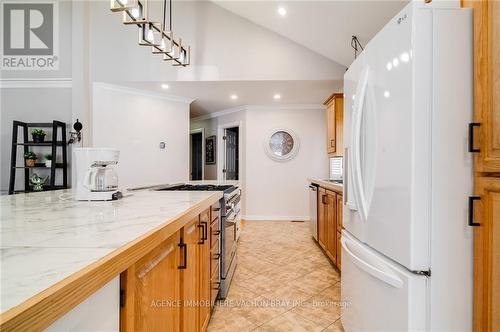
[191,105,328,220]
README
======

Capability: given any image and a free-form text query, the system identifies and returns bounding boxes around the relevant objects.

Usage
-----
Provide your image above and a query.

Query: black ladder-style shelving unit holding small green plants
[9,120,68,195]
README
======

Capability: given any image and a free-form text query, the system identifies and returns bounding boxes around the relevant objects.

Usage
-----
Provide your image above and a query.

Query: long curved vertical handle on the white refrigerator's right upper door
[351,66,370,221]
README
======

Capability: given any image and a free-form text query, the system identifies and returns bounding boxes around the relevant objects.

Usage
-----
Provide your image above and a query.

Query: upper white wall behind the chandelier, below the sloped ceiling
[88,1,345,82]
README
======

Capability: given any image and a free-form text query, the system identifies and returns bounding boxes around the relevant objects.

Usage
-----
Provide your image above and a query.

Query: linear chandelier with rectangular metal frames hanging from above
[111,0,191,67]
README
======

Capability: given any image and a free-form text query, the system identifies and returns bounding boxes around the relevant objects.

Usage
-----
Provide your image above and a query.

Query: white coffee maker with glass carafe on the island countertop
[74,148,120,201]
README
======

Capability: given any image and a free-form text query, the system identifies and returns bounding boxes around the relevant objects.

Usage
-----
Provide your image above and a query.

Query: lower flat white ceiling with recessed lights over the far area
[120,81,342,117]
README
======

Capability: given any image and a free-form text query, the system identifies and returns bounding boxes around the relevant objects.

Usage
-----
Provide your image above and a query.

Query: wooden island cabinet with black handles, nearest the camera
[120,210,218,332]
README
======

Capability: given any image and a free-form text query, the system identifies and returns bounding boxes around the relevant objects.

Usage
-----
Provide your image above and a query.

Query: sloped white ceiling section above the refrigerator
[212,0,408,66]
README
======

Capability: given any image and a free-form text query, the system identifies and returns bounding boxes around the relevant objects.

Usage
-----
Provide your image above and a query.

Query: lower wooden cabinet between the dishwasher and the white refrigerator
[318,187,342,270]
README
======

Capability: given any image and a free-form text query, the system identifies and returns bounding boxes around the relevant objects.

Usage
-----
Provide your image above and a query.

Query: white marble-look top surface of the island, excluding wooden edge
[0,190,222,313]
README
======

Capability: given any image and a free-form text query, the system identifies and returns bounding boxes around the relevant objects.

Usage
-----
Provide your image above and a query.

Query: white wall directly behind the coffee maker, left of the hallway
[92,83,189,188]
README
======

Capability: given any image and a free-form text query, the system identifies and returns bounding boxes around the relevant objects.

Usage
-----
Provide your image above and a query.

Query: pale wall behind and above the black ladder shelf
[0,0,73,194]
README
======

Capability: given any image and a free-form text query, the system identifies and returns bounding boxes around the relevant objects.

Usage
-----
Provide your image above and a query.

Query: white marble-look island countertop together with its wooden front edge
[0,190,222,331]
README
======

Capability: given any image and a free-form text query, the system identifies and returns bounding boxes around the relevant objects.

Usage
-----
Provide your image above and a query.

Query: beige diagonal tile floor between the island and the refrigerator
[208,221,343,332]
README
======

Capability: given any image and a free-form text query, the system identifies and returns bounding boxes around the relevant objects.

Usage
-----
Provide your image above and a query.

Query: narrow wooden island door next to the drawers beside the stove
[199,210,211,331]
